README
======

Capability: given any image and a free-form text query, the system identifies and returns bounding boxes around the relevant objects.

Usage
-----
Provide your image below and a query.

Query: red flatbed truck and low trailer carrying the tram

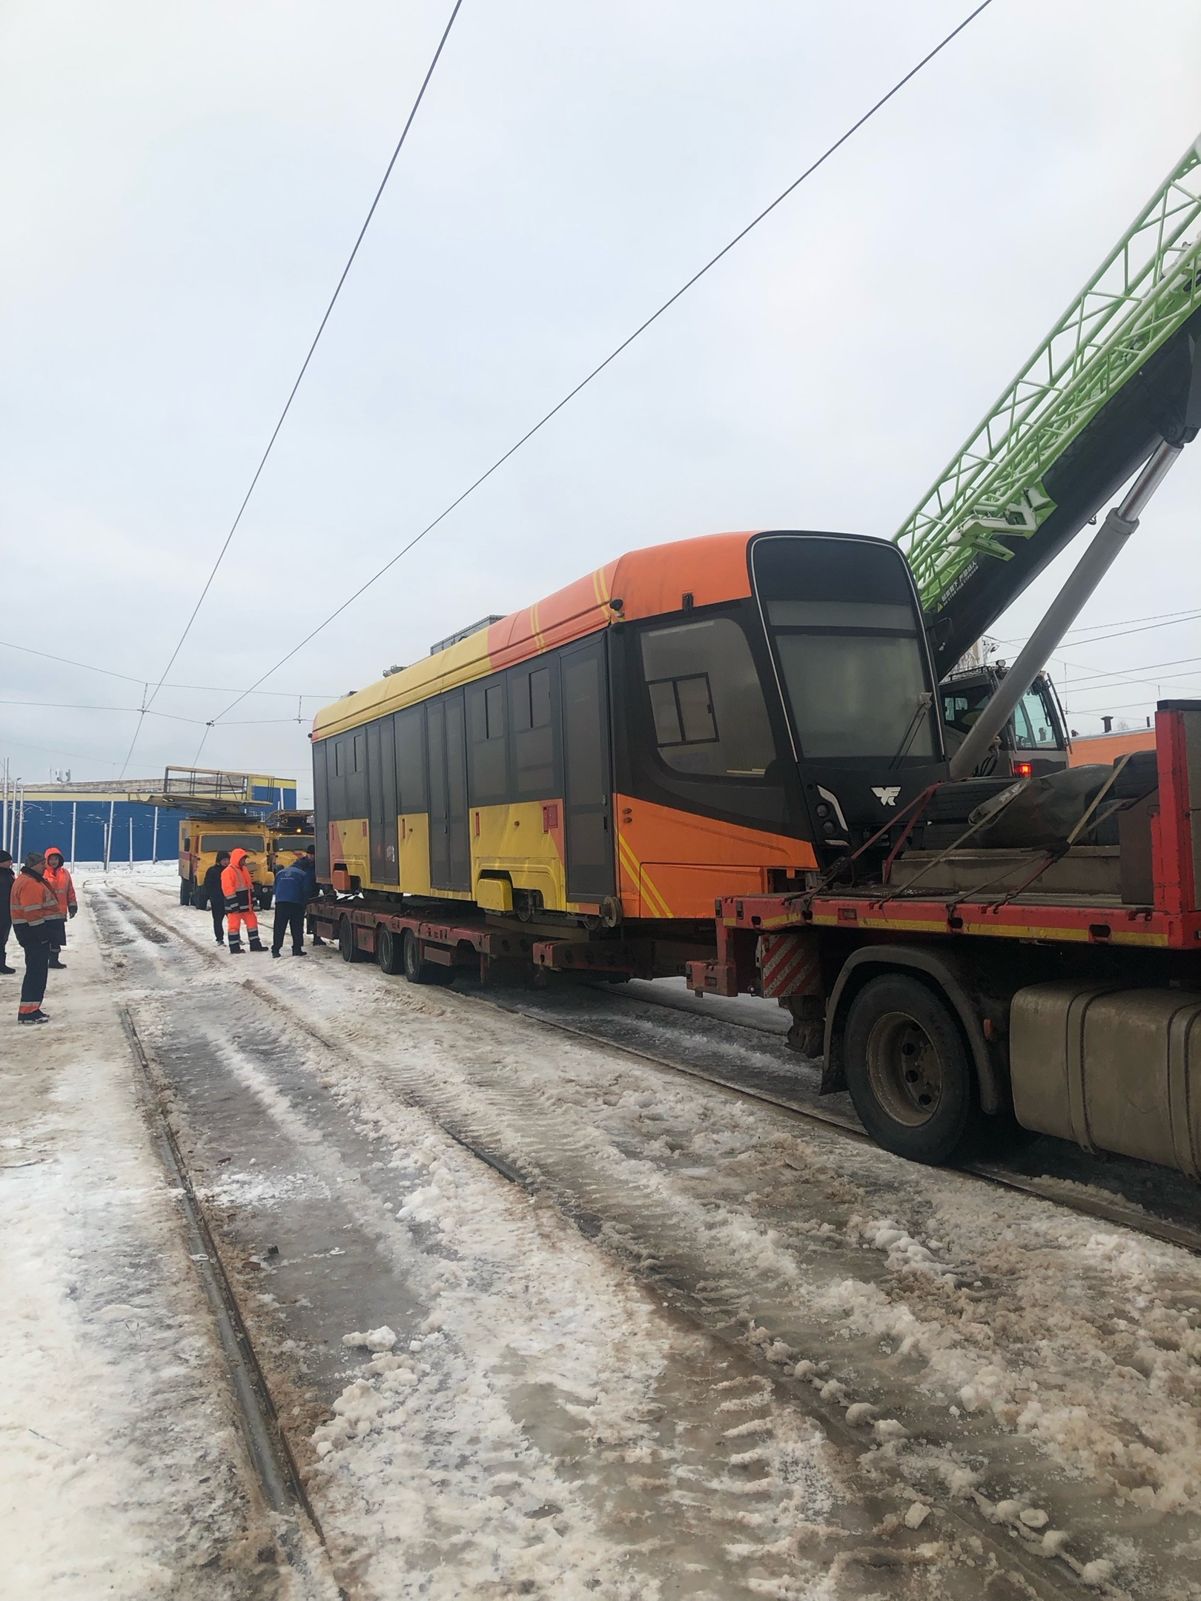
[315,703,1201,1178]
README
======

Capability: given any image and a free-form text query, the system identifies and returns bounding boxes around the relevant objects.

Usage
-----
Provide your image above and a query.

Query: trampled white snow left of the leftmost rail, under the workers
[0,877,339,1601]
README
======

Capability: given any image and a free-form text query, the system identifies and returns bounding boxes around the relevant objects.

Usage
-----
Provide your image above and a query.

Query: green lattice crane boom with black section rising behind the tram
[895,129,1201,671]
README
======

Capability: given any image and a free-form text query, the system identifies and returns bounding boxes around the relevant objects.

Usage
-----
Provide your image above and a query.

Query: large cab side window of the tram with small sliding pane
[641,616,775,780]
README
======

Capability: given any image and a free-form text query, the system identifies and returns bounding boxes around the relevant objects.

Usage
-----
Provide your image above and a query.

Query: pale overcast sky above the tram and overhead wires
[0,0,1201,800]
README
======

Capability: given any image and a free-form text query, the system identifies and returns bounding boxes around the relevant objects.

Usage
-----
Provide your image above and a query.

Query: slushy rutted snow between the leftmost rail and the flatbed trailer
[28,874,1201,1601]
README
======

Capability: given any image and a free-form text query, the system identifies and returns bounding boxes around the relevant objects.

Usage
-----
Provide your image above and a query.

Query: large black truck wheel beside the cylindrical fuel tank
[846,973,983,1164]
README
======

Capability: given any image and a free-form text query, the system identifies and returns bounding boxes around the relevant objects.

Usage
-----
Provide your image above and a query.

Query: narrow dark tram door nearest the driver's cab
[560,636,617,901]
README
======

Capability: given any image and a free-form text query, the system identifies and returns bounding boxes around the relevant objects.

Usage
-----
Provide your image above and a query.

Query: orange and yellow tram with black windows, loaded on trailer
[312,532,943,927]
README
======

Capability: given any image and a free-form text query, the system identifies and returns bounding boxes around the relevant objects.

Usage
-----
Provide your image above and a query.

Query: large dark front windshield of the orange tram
[751,533,938,765]
